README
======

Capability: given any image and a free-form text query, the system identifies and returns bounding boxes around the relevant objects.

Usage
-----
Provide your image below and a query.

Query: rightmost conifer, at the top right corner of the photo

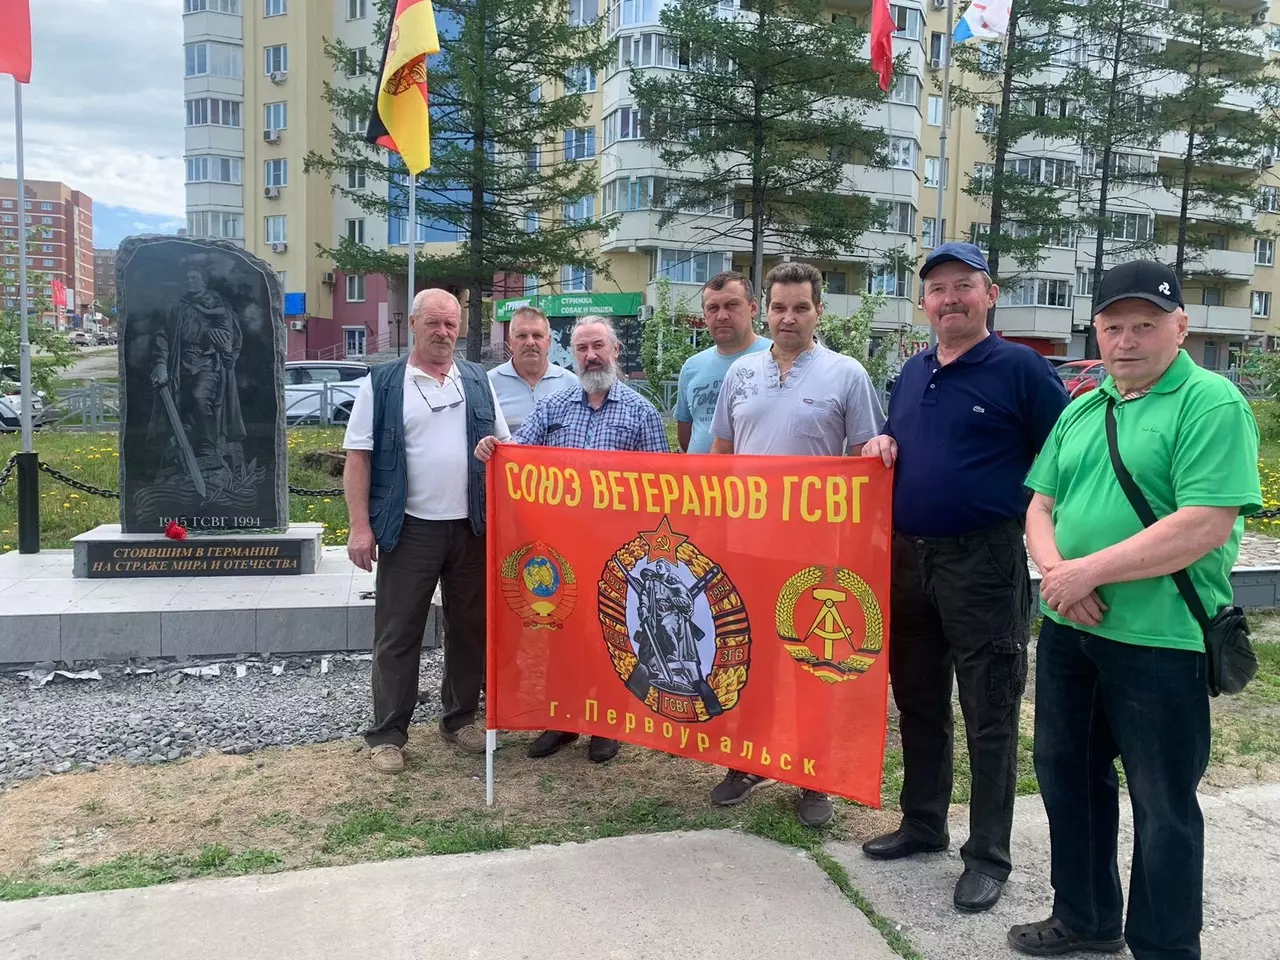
[1164,0,1280,276]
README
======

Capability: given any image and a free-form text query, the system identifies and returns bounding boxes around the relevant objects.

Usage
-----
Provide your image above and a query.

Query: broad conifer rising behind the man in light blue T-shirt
[623,0,887,296]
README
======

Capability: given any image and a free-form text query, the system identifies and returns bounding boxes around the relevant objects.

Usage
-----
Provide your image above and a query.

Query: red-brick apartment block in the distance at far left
[0,178,95,326]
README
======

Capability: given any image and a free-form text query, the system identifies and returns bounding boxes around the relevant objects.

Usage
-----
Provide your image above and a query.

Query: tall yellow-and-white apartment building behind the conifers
[183,0,1280,367]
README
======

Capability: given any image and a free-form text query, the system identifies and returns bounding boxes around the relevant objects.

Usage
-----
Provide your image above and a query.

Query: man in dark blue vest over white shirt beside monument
[343,289,511,773]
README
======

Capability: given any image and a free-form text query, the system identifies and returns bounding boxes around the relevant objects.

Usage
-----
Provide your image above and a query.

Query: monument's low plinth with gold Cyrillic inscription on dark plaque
[72,524,324,580]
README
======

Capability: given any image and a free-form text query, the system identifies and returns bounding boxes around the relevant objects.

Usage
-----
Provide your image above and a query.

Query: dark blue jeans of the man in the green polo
[1036,617,1210,960]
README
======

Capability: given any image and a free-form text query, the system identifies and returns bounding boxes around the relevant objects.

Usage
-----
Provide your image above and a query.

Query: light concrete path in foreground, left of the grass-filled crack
[0,832,896,960]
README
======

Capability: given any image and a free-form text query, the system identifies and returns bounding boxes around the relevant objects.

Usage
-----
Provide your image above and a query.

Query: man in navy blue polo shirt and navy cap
[863,243,1068,911]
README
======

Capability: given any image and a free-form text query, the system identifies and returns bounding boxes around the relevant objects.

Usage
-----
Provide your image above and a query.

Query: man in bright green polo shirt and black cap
[1009,261,1262,960]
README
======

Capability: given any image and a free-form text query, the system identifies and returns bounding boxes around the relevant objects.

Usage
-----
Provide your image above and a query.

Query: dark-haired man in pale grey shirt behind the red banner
[712,262,884,827]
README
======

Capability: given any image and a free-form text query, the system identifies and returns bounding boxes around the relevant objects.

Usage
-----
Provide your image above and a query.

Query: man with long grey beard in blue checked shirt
[475,316,671,763]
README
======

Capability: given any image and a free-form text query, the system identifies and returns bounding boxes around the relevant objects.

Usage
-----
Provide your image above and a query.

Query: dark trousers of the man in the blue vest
[365,515,486,746]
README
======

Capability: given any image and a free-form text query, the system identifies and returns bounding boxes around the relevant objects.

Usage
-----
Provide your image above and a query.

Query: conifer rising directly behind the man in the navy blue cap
[951,0,1079,326]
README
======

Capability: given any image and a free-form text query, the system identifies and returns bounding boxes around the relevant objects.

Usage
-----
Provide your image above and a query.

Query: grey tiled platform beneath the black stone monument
[0,547,444,664]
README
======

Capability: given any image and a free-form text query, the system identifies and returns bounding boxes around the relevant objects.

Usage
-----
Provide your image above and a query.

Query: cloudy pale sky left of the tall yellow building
[0,0,186,252]
